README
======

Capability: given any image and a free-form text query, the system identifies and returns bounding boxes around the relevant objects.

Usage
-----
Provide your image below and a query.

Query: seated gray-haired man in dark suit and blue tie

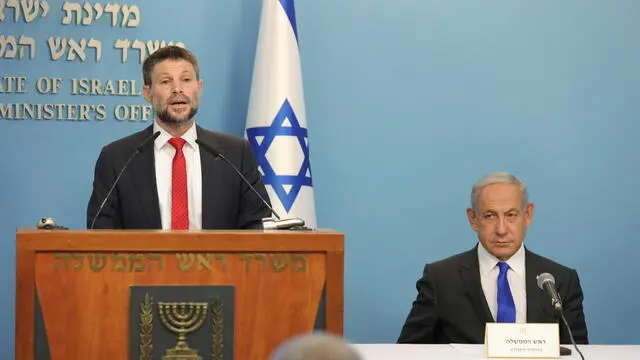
[398,173,588,344]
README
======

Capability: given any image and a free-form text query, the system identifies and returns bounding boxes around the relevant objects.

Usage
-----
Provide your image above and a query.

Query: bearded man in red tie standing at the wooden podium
[87,46,271,230]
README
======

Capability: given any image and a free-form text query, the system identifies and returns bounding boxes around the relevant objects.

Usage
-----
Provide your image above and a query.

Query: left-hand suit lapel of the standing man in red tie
[131,126,162,229]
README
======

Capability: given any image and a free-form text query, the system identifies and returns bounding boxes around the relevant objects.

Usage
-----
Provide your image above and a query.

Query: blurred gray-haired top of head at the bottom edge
[270,332,362,360]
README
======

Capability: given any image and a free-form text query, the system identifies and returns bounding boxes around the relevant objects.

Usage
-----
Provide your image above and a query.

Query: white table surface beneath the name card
[354,344,640,360]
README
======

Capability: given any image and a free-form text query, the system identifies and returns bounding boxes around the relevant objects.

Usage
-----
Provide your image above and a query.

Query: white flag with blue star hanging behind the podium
[246,0,317,228]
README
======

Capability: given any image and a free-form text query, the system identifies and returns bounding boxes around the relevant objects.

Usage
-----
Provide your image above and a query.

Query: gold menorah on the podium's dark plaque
[158,302,207,360]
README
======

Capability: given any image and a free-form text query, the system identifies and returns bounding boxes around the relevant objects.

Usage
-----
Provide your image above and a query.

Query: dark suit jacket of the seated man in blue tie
[398,246,588,344]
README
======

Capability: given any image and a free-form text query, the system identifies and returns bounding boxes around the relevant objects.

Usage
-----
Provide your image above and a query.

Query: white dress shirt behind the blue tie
[478,244,527,324]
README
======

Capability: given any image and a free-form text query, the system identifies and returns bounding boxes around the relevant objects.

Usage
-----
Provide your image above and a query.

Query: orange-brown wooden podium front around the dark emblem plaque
[16,229,344,360]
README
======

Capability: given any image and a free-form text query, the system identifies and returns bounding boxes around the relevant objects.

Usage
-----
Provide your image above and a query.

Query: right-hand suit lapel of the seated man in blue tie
[524,248,553,323]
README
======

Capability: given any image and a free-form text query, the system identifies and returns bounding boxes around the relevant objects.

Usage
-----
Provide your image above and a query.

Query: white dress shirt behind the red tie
[153,121,202,230]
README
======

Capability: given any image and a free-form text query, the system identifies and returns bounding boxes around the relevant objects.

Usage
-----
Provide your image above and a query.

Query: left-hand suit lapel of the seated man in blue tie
[460,246,494,322]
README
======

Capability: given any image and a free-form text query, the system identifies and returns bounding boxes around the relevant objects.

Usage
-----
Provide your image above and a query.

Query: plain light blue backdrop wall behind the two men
[0,0,640,354]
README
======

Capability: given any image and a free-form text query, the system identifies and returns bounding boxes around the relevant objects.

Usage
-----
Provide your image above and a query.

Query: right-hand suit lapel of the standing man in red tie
[196,126,224,229]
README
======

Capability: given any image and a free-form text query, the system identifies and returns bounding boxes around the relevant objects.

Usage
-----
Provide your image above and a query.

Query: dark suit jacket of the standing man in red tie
[87,126,271,229]
